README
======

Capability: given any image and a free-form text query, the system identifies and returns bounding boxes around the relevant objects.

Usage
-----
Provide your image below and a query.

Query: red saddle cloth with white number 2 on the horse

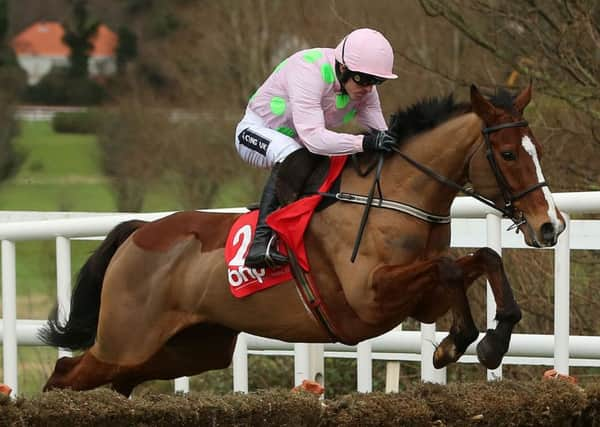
[225,156,347,298]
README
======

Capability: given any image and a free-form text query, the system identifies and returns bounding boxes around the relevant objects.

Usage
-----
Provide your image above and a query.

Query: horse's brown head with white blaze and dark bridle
[469,85,565,247]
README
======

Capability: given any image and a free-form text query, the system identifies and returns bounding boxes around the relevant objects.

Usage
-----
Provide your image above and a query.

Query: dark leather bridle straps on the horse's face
[481,120,548,230]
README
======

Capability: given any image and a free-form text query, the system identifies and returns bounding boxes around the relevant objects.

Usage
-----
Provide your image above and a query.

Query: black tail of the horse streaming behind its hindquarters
[38,220,145,350]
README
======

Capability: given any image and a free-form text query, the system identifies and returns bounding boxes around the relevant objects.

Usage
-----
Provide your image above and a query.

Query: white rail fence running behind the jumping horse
[0,192,600,395]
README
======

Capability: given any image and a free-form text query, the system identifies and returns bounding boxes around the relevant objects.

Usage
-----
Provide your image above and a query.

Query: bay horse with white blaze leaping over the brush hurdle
[41,85,565,396]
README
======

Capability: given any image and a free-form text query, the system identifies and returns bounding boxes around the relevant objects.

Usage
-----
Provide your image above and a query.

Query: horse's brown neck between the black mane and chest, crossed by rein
[385,113,482,214]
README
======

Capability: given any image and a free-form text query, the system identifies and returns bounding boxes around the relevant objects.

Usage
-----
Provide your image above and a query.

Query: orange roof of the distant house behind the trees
[11,22,118,56]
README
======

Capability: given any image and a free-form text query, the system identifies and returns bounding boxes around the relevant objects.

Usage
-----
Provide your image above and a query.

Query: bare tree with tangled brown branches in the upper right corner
[415,0,600,190]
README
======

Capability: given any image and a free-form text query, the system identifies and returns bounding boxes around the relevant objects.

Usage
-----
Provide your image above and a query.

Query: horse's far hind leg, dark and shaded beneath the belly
[112,324,238,396]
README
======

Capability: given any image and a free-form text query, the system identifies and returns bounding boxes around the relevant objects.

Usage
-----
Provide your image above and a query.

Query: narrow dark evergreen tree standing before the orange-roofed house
[63,0,100,78]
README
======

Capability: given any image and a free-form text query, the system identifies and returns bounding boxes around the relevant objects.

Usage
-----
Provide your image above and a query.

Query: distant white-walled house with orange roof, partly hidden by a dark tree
[11,22,118,85]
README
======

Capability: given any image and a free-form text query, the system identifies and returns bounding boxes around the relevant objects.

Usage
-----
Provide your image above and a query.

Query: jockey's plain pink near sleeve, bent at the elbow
[287,63,363,155]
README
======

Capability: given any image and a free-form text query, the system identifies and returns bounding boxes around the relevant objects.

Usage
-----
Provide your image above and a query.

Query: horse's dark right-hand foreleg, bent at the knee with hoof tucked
[457,248,521,369]
